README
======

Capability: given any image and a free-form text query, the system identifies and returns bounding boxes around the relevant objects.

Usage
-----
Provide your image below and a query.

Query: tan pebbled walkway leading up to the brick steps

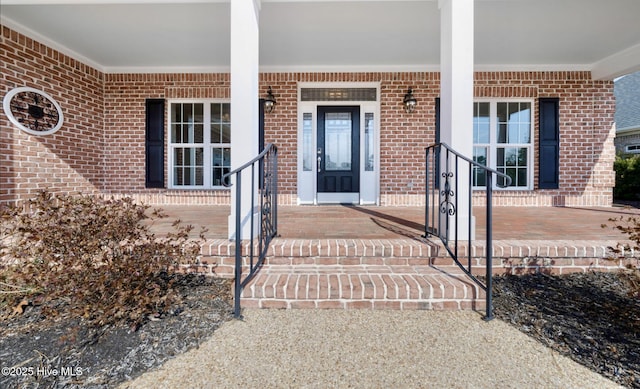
[121,310,619,388]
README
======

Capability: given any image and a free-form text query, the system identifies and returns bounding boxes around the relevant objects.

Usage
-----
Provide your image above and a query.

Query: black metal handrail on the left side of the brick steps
[222,143,278,318]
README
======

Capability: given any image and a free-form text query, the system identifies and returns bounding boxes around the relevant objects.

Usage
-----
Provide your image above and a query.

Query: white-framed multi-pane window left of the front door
[169,102,231,189]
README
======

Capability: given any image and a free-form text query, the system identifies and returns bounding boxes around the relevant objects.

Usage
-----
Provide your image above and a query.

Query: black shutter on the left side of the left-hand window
[145,99,164,188]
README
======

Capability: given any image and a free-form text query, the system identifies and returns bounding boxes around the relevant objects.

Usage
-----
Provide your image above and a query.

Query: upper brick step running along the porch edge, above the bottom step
[192,235,633,277]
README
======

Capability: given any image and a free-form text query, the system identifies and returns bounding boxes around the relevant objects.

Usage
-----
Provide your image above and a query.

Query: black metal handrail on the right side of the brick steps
[424,143,511,320]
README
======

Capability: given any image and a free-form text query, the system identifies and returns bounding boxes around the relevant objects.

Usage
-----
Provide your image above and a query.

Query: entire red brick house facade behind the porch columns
[0,27,615,205]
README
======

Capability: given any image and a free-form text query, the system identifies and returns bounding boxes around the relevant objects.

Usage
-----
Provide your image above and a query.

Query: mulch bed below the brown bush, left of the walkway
[0,275,232,388]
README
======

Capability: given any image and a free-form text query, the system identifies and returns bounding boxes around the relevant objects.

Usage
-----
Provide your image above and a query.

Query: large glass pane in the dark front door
[324,112,351,171]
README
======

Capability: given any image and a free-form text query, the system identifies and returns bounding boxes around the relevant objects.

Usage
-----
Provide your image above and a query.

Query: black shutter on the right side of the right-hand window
[538,98,560,189]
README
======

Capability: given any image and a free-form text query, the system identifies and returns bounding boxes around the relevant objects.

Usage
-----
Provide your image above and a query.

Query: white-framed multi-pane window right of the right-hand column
[472,101,533,189]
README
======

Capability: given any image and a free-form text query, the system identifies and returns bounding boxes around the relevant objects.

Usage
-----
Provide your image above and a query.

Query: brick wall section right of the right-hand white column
[475,72,615,206]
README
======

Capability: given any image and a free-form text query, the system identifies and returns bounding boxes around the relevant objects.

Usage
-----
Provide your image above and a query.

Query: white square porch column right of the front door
[438,0,474,239]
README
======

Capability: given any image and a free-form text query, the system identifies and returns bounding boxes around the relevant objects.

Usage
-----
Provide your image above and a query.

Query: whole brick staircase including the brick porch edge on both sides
[185,233,631,312]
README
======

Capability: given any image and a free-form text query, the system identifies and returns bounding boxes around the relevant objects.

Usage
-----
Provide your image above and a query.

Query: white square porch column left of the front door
[229,0,260,238]
